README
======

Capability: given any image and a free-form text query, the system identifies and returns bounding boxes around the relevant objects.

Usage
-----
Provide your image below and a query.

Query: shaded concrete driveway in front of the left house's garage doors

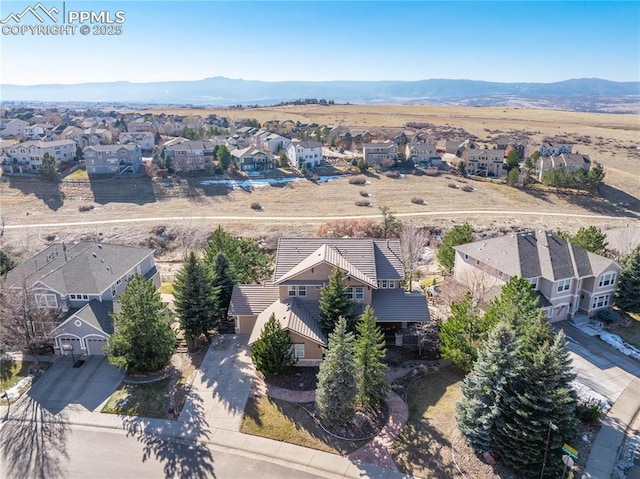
[25,356,124,414]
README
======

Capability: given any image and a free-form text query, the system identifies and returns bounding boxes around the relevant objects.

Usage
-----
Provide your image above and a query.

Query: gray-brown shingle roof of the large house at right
[455,231,615,281]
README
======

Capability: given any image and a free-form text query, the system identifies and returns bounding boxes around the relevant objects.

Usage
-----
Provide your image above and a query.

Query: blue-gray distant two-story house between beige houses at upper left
[82,143,142,176]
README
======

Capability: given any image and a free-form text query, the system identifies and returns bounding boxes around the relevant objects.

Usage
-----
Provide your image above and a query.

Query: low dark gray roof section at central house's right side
[371,289,430,323]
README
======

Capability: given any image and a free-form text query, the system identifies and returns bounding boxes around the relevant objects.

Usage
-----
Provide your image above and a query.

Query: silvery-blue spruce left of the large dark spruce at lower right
[456,323,520,452]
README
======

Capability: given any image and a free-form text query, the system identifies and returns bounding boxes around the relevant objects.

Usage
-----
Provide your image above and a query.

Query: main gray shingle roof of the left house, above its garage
[7,241,154,295]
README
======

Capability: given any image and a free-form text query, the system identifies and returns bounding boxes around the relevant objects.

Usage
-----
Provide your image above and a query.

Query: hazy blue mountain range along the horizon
[0,77,640,111]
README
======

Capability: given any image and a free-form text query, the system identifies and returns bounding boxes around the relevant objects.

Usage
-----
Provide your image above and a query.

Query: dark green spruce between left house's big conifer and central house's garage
[173,252,220,346]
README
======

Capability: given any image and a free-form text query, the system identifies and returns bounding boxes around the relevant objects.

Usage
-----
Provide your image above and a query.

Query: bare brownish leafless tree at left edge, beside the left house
[0,281,60,369]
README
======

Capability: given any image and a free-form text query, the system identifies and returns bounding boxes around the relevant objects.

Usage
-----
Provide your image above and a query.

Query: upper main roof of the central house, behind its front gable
[273,238,404,285]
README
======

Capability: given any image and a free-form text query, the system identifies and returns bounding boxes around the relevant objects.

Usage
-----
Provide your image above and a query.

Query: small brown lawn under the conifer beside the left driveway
[102,377,175,419]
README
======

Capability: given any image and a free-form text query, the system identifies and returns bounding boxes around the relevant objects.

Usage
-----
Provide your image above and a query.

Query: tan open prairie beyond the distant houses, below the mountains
[139,105,640,202]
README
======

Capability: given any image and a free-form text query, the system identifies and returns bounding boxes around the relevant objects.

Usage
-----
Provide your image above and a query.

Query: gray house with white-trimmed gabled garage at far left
[6,241,160,355]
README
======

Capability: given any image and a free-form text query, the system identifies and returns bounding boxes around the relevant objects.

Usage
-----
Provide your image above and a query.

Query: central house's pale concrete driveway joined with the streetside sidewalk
[0,335,411,479]
